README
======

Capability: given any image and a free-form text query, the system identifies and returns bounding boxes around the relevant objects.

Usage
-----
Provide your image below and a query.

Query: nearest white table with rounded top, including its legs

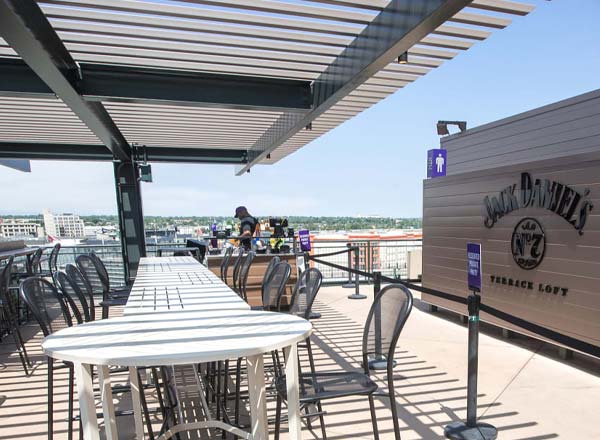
[42,310,312,440]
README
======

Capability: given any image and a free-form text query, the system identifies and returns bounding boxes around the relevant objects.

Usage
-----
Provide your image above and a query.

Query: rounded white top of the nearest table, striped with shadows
[42,310,312,367]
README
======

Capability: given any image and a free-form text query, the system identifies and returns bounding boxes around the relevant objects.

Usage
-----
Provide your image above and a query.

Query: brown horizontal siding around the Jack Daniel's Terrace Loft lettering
[423,155,600,345]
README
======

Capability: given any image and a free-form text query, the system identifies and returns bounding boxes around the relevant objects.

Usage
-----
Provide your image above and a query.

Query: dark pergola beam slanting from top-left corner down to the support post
[0,0,131,161]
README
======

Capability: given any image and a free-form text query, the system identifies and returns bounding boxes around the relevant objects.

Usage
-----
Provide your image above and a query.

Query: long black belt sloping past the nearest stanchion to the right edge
[309,255,600,358]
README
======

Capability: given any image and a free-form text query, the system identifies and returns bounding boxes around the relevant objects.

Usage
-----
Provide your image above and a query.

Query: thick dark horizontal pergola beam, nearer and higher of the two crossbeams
[0,58,312,112]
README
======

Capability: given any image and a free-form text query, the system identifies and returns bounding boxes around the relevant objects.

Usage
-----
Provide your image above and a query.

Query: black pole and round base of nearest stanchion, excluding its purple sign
[444,292,498,440]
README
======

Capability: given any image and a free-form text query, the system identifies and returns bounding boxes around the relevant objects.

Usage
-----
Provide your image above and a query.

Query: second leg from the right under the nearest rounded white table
[246,354,268,440]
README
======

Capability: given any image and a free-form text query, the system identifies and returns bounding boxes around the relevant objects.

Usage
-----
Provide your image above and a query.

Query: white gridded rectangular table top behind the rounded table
[123,256,250,316]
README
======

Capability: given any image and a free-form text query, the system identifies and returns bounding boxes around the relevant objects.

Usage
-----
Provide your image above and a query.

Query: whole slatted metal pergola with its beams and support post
[0,0,533,278]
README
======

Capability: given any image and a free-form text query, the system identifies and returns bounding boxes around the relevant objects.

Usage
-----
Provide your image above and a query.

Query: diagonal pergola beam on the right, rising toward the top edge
[237,0,471,175]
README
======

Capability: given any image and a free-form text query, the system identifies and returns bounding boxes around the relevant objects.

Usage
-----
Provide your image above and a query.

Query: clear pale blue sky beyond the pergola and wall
[0,0,600,217]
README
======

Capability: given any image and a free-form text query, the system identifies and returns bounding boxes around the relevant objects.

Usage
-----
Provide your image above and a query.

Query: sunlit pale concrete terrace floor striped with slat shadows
[0,286,600,440]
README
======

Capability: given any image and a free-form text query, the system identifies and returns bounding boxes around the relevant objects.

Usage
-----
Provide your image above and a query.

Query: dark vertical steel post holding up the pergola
[114,162,146,283]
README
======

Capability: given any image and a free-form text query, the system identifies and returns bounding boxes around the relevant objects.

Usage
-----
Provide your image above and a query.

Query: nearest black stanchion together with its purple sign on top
[444,243,498,440]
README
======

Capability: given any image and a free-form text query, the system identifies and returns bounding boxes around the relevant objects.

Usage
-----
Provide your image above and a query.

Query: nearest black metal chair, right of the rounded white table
[275,284,413,440]
